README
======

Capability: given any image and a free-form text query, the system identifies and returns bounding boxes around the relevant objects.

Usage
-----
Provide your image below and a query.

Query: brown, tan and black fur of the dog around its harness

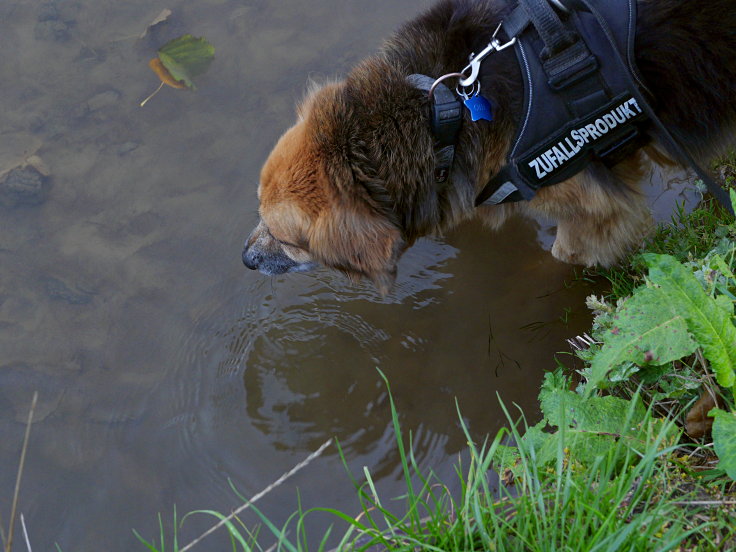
[243,0,736,291]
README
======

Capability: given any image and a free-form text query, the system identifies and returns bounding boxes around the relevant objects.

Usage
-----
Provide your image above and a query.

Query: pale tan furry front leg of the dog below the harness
[529,156,654,267]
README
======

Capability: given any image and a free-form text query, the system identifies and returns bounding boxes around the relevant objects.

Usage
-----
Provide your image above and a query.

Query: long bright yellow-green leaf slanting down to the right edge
[644,253,736,387]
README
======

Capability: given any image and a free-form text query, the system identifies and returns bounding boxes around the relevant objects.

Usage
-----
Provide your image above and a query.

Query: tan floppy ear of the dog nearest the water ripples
[309,198,406,296]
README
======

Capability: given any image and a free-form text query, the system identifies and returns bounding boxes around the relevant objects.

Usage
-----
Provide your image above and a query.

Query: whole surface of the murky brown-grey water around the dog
[0,0,700,552]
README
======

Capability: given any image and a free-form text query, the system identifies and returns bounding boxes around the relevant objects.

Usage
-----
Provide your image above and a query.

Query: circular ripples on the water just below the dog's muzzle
[158,236,456,492]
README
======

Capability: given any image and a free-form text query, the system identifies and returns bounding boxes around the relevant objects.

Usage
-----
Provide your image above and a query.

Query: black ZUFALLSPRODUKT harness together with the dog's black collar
[409,0,731,213]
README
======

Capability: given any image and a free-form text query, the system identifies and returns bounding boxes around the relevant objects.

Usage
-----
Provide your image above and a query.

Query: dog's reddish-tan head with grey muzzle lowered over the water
[243,77,431,293]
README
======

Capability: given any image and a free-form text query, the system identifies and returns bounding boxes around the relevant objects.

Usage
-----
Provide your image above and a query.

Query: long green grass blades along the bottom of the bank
[134,386,734,552]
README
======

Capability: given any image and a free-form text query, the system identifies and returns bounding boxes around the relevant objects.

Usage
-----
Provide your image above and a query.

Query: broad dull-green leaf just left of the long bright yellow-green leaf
[585,282,697,394]
